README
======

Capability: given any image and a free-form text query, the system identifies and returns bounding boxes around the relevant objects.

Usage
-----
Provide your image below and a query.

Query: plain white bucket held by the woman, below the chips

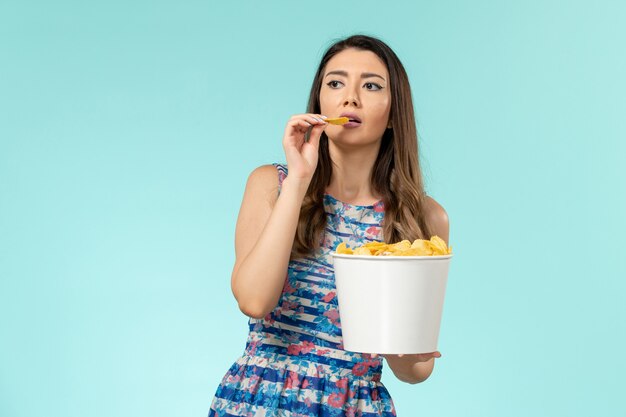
[333,253,452,354]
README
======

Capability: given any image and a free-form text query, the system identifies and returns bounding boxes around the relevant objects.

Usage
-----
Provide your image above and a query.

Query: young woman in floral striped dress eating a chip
[209,35,449,416]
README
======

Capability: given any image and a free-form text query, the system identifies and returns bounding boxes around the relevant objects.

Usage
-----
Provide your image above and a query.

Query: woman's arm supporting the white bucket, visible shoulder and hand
[384,197,450,384]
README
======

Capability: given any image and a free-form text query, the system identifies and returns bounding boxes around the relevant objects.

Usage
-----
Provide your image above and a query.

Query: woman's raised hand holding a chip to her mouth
[283,113,328,181]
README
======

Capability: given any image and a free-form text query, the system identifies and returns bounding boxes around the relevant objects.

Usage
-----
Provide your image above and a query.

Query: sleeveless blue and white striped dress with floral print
[209,164,396,417]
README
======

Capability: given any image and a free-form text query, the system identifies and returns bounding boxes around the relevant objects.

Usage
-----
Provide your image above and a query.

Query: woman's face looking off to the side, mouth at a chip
[320,48,391,144]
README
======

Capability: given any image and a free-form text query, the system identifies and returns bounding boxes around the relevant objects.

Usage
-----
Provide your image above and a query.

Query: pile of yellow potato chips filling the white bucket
[337,236,452,256]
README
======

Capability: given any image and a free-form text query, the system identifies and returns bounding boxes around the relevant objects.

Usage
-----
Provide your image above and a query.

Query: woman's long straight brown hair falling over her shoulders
[292,35,430,257]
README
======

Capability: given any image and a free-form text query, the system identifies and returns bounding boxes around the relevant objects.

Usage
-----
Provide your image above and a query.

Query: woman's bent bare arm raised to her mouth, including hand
[231,114,327,318]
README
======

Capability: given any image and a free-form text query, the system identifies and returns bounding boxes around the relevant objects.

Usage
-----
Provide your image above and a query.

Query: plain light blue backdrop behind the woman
[0,0,626,417]
